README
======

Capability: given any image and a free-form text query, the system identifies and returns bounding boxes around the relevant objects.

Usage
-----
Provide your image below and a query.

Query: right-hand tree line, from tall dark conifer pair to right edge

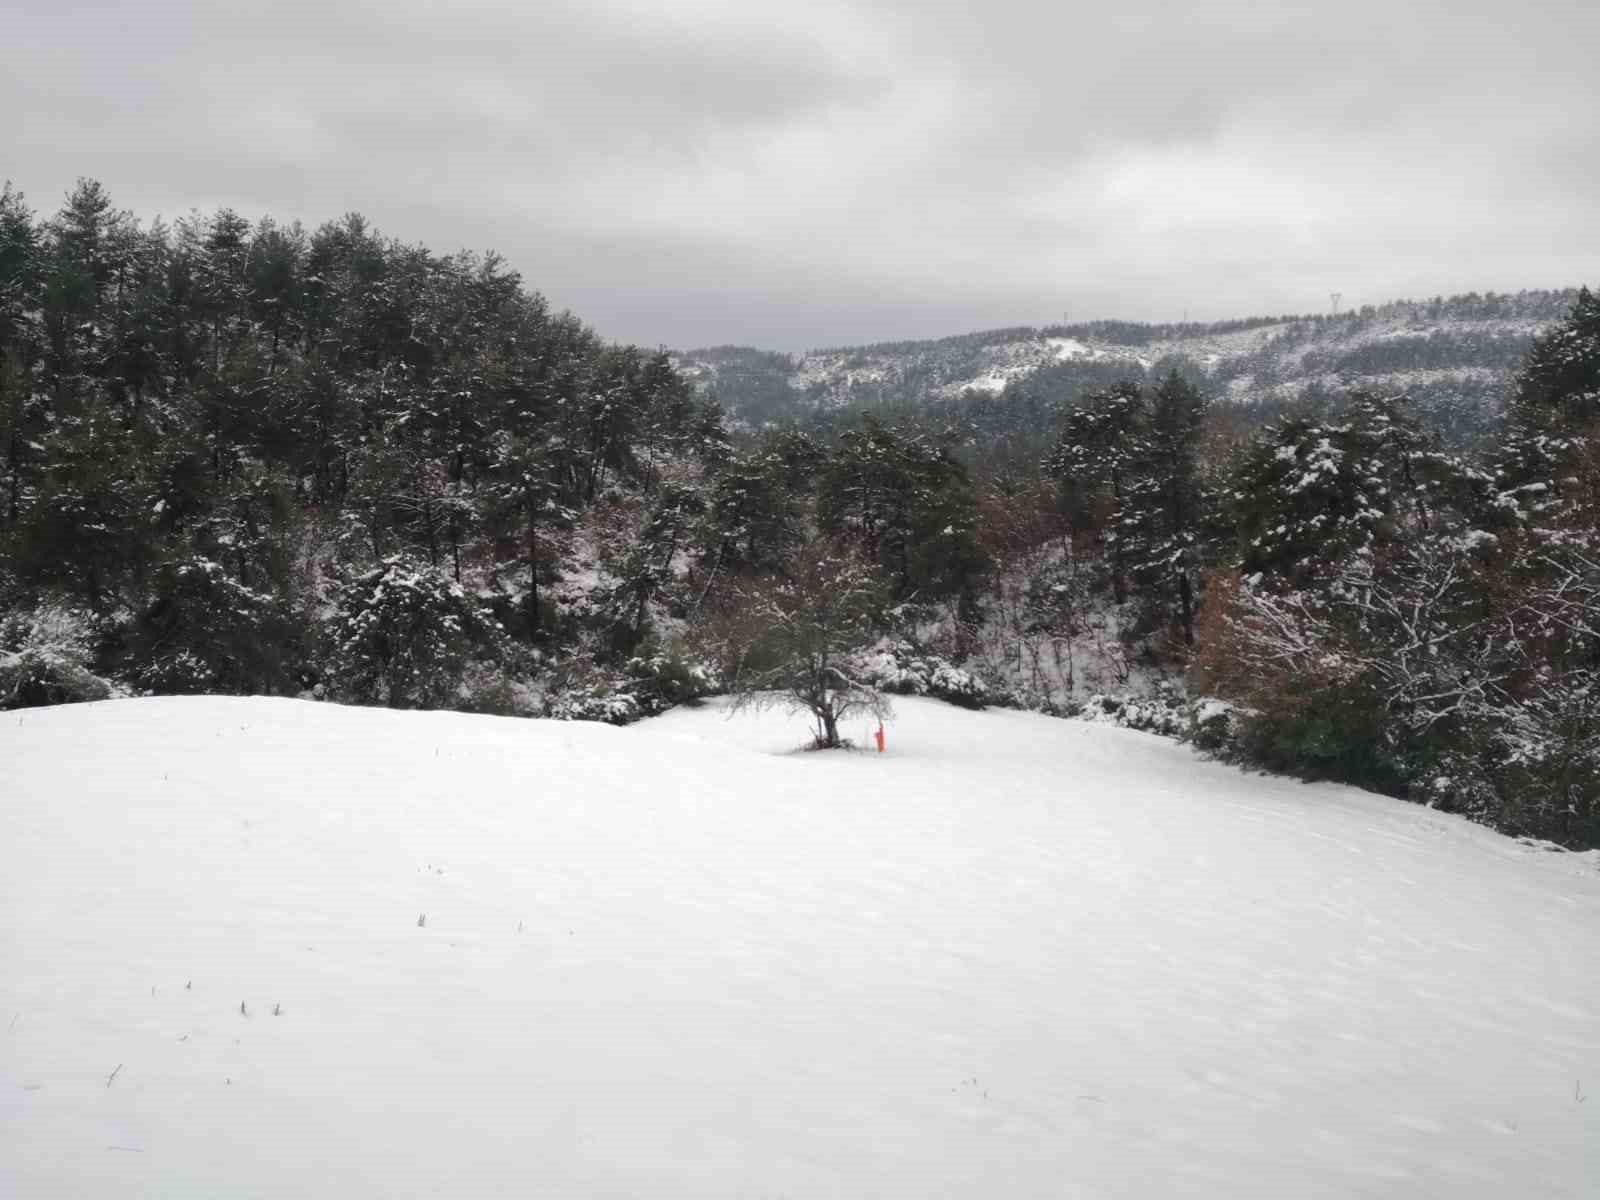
[1042,290,1600,845]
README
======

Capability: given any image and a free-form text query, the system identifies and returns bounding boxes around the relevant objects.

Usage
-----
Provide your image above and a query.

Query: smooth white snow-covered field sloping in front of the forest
[0,699,1600,1200]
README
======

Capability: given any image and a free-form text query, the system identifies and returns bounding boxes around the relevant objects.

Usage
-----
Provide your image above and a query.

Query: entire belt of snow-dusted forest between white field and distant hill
[0,181,1600,845]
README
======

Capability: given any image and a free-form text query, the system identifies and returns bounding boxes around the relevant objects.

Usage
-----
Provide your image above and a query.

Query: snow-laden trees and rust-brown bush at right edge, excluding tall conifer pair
[1194,291,1600,846]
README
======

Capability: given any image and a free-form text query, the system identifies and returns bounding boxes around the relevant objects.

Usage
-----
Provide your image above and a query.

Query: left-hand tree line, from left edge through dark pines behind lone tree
[0,181,981,715]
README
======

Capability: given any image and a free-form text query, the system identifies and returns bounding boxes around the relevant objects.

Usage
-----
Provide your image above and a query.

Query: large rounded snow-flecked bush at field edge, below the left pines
[331,557,502,709]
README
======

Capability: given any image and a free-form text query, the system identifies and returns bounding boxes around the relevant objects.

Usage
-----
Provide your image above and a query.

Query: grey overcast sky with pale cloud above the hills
[0,0,1600,350]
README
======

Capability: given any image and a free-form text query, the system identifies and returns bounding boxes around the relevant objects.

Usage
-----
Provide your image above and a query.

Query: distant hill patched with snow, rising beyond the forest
[675,288,1576,445]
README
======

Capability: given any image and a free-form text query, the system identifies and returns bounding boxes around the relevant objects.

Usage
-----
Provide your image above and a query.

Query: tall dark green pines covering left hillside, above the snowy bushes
[0,181,728,690]
